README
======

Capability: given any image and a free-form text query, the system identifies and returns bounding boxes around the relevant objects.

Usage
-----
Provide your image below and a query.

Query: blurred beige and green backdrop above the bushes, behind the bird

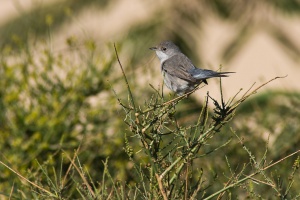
[0,0,300,96]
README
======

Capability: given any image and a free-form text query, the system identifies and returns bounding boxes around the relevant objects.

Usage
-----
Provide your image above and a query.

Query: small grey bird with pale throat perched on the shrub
[150,41,234,96]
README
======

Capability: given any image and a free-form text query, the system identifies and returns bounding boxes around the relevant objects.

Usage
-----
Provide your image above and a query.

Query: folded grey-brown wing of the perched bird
[162,54,198,83]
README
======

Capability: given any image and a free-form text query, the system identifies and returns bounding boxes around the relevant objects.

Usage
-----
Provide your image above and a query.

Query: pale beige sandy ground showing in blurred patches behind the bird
[0,0,300,99]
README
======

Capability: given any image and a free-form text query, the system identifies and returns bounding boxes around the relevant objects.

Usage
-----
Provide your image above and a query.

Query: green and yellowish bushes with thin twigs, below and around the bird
[0,0,300,199]
